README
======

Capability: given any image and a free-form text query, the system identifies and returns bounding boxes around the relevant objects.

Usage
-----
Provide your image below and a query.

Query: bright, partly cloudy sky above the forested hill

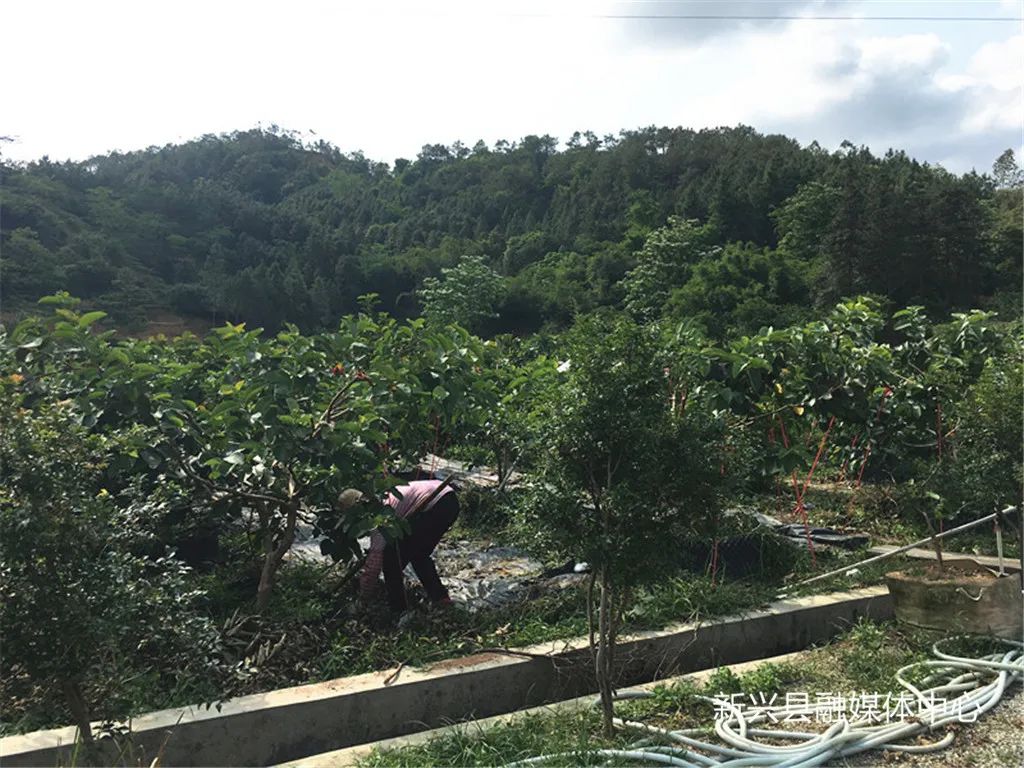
[0,0,1024,172]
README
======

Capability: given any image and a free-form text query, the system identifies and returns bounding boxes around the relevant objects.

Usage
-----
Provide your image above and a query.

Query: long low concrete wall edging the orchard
[0,587,892,768]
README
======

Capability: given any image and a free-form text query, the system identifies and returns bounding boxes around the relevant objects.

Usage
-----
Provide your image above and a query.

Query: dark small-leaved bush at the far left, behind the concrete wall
[0,393,219,744]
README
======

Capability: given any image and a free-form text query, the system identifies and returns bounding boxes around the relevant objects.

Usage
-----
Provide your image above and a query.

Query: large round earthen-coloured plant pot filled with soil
[886,559,1024,640]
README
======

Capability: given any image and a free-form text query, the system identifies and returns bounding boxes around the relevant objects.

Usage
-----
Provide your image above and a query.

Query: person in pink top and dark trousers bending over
[359,480,459,611]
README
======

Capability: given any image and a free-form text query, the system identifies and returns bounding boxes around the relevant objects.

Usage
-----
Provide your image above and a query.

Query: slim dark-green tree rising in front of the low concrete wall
[526,317,722,734]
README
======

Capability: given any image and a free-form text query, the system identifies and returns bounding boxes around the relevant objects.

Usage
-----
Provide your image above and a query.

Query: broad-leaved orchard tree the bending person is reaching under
[152,315,495,610]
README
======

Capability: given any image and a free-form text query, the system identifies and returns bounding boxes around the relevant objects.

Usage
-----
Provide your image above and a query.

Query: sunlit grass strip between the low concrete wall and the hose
[358,621,950,768]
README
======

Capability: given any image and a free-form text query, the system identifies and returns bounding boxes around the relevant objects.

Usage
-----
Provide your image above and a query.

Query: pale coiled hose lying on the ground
[505,638,1024,768]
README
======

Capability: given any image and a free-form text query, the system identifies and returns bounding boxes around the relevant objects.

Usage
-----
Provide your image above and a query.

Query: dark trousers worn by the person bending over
[383,494,459,610]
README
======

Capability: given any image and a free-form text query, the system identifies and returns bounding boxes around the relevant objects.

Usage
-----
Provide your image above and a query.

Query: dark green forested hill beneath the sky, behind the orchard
[0,127,1022,335]
